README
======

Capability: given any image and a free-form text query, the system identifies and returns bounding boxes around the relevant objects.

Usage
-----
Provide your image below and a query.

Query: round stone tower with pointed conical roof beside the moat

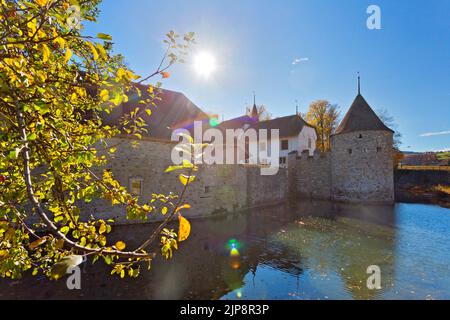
[331,81,394,204]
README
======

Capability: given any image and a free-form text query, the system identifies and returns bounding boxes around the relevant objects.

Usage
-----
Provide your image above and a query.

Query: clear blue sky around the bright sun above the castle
[85,0,450,151]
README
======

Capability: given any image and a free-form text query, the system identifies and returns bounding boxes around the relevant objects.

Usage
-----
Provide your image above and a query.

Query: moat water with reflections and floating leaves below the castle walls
[0,201,450,300]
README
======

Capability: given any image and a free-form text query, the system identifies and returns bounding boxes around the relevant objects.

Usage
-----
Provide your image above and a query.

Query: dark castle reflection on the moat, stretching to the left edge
[0,202,396,299]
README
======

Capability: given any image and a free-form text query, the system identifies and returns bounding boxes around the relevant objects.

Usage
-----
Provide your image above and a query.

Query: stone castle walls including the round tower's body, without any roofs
[83,131,394,223]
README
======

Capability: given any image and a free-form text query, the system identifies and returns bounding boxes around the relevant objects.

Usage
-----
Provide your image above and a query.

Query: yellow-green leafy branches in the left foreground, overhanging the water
[0,0,196,279]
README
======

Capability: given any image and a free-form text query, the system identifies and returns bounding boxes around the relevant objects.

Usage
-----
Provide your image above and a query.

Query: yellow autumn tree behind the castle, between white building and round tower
[305,100,339,152]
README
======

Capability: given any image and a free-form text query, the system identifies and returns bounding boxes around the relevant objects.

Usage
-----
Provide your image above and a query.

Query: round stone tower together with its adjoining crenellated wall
[289,92,394,204]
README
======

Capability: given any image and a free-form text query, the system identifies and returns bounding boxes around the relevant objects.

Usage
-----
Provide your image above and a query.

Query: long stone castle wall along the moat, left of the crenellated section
[82,138,288,223]
